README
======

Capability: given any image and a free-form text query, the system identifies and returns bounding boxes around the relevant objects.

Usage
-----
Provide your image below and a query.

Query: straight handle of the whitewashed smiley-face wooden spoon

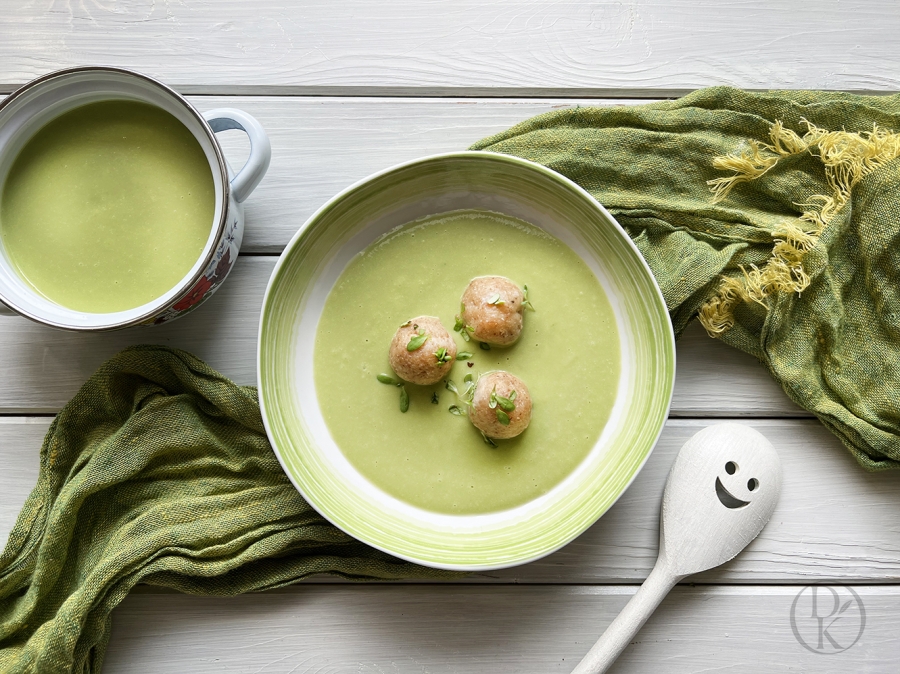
[572,560,683,674]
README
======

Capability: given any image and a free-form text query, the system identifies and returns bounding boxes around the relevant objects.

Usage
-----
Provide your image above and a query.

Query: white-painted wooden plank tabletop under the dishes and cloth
[0,0,900,674]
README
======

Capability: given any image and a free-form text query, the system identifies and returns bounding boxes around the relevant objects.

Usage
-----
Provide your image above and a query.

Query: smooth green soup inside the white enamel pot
[0,101,215,313]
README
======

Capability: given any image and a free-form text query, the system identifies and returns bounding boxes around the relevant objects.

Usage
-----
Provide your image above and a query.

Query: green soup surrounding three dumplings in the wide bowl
[314,211,620,514]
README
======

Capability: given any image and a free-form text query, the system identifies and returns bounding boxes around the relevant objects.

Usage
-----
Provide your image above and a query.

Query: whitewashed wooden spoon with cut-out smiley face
[573,424,781,674]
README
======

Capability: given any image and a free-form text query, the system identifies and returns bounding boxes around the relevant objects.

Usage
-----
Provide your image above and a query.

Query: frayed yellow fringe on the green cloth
[699,119,900,337]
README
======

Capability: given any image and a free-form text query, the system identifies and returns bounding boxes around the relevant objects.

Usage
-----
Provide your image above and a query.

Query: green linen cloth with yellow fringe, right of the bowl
[473,87,900,470]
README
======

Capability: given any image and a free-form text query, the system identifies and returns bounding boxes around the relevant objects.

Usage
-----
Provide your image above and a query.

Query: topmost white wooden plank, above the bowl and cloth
[0,0,900,95]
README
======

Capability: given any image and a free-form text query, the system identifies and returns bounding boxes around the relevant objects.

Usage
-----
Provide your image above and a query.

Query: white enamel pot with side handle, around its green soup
[0,67,272,330]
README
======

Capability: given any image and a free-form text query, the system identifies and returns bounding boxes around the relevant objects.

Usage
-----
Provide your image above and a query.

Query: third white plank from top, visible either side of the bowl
[0,255,805,416]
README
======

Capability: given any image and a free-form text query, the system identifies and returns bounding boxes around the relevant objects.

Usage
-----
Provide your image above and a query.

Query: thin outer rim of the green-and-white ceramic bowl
[256,150,677,572]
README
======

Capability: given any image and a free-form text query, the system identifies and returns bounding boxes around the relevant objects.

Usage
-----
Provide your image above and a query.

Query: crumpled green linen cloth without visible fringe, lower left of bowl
[0,346,453,674]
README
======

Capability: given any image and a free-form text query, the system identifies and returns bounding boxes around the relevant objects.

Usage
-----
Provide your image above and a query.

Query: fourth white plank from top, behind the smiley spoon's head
[0,419,900,584]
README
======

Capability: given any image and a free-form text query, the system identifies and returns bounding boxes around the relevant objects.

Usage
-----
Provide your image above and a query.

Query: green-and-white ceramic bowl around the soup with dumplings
[258,152,675,570]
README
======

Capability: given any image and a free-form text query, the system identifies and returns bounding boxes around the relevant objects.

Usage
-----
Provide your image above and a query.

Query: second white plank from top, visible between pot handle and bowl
[191,96,628,253]
